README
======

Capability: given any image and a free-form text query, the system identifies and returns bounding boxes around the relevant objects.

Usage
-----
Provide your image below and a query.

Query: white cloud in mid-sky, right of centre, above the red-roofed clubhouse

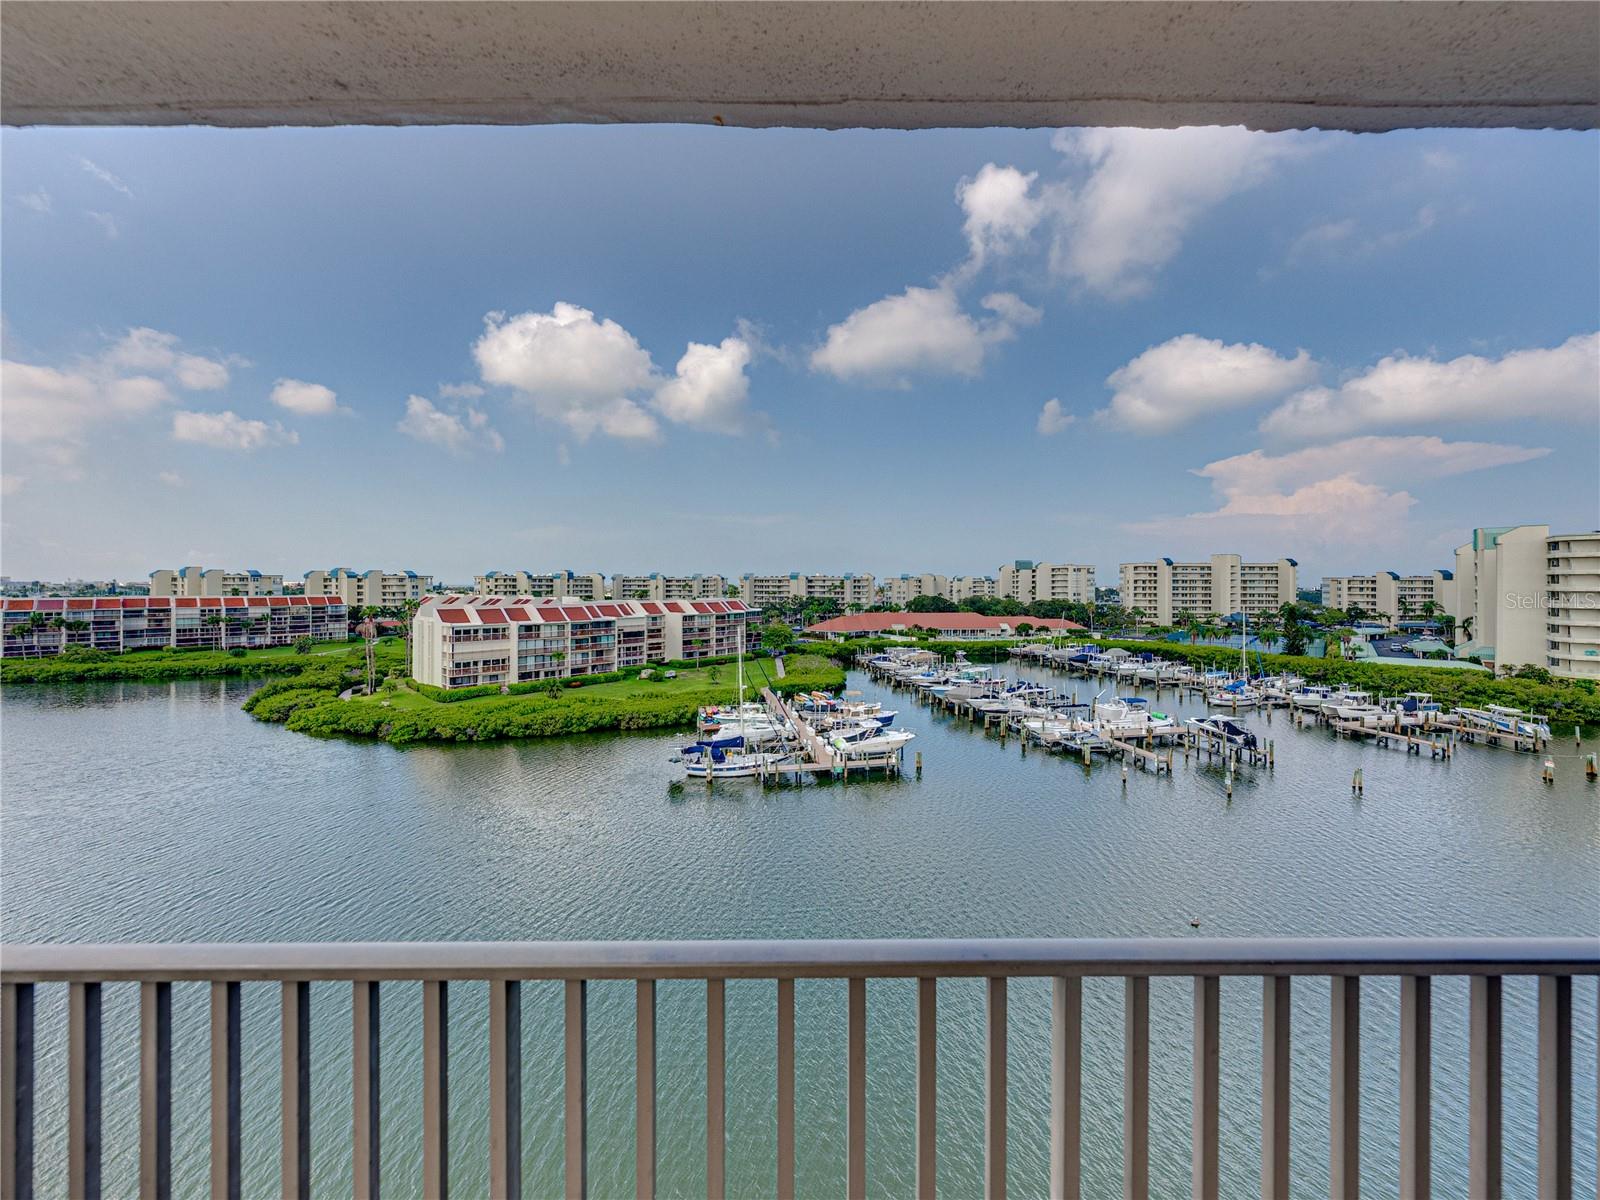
[811,285,1040,386]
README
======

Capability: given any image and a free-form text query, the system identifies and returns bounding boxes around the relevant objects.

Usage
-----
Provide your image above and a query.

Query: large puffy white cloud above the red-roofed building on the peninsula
[472,301,661,440]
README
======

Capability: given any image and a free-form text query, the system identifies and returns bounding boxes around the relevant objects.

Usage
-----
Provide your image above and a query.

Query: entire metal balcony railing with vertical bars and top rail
[0,938,1600,1200]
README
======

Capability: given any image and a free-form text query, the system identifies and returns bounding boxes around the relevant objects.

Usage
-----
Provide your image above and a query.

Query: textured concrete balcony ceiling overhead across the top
[0,0,1600,130]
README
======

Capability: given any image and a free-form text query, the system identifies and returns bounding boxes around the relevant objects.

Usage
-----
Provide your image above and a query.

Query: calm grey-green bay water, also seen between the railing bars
[0,678,1600,1197]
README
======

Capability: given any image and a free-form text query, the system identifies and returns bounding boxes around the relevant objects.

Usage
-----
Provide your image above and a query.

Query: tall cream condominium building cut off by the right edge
[1451,525,1600,678]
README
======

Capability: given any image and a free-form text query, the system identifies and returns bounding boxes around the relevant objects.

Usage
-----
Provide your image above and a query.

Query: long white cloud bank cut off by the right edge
[1261,333,1600,440]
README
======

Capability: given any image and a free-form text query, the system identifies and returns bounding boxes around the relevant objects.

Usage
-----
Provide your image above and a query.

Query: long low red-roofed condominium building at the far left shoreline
[0,595,349,658]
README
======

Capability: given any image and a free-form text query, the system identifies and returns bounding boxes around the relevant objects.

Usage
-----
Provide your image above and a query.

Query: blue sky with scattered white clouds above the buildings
[0,126,1600,584]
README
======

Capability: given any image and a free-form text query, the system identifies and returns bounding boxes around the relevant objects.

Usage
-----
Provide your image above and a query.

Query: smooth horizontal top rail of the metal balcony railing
[0,938,1600,984]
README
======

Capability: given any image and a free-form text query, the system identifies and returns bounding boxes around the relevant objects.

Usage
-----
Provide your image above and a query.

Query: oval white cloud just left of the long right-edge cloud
[1096,333,1317,434]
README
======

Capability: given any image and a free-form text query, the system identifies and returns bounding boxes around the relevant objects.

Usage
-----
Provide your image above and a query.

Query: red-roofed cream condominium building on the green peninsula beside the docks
[411,595,758,688]
